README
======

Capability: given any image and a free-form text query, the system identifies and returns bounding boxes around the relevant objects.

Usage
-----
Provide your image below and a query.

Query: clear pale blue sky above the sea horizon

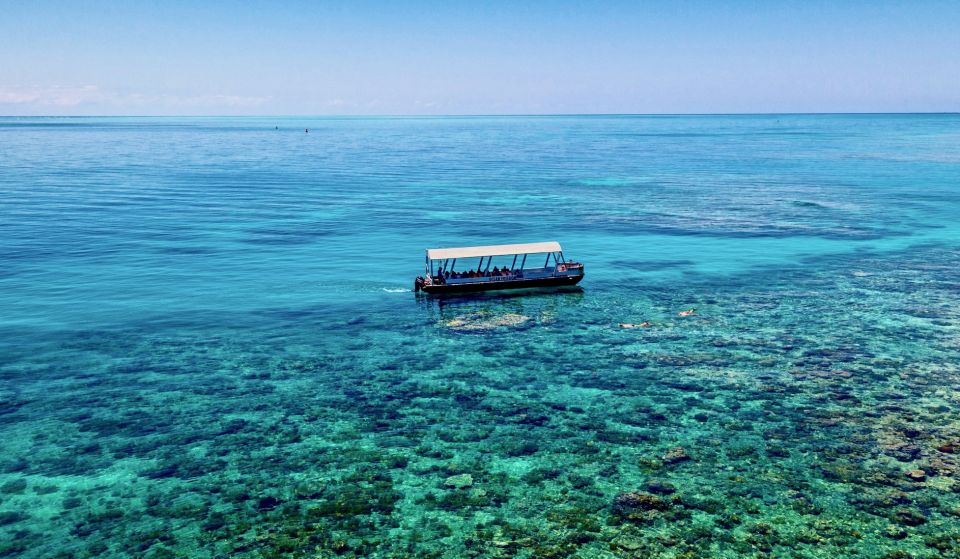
[0,0,960,115]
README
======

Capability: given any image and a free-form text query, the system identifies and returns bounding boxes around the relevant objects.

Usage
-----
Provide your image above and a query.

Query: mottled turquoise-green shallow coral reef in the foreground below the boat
[0,245,960,559]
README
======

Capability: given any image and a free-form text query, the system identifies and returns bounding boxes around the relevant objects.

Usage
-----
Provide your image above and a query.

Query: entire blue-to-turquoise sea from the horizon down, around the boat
[0,115,960,559]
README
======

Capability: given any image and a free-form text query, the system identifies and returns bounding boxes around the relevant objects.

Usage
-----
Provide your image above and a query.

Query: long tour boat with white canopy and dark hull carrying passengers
[413,241,583,294]
